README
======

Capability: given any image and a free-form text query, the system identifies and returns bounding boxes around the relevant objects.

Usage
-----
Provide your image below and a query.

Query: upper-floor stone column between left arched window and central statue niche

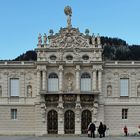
[58,65,63,92]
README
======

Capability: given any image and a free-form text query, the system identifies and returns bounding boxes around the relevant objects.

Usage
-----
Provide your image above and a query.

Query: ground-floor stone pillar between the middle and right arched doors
[75,95,81,134]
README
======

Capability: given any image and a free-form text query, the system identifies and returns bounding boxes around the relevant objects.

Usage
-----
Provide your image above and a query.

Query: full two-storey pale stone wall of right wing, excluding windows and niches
[102,63,140,135]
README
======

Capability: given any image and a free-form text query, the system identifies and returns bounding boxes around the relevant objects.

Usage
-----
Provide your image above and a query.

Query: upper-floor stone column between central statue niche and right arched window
[75,65,80,92]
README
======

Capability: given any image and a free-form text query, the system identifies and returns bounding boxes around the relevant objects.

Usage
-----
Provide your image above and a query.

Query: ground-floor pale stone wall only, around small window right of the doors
[105,103,140,135]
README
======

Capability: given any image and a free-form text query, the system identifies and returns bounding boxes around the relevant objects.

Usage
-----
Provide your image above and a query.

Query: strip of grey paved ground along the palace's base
[0,136,140,140]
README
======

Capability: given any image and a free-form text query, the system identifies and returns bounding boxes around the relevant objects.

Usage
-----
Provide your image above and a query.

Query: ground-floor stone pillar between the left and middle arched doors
[57,94,64,134]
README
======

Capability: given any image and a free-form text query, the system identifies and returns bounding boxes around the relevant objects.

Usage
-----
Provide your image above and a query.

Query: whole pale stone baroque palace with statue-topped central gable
[0,6,140,135]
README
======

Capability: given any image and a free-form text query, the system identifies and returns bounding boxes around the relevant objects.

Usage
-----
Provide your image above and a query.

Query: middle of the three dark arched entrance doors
[64,110,75,134]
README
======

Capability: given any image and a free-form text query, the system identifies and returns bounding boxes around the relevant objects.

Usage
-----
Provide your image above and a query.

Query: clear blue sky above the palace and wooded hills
[0,0,140,59]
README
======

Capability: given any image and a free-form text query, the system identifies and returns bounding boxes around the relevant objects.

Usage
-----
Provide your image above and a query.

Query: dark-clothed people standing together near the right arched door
[87,122,106,138]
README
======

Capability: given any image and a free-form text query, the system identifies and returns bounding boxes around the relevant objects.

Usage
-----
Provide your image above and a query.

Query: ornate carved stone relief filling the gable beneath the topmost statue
[49,28,90,48]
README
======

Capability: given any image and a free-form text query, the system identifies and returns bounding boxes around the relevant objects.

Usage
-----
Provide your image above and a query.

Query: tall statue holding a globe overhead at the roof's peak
[64,6,72,28]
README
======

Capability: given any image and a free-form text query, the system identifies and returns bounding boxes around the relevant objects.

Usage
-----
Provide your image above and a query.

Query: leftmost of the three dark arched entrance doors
[47,110,58,134]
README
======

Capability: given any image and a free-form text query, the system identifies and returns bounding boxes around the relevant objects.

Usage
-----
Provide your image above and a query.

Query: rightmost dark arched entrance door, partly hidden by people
[81,110,92,134]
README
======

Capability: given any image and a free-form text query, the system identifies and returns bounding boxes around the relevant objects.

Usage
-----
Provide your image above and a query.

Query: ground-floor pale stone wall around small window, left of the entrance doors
[0,104,35,135]
